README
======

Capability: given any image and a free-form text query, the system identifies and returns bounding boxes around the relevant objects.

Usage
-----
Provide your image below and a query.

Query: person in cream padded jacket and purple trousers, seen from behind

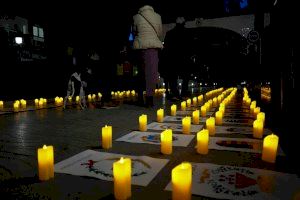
[133,5,163,107]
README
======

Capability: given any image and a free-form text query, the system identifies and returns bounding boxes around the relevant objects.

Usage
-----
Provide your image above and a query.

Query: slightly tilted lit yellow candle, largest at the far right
[262,134,279,163]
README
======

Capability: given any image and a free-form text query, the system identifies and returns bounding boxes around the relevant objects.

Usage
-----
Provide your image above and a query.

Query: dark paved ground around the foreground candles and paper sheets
[0,93,300,199]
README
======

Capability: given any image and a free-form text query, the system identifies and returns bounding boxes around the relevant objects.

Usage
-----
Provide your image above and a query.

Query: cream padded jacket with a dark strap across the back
[133,5,163,49]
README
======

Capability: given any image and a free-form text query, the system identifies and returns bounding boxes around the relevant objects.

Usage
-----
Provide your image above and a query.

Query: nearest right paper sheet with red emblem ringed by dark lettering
[165,163,300,200]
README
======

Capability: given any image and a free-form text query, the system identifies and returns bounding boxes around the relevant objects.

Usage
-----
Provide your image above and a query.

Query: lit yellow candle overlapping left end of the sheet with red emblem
[172,162,192,200]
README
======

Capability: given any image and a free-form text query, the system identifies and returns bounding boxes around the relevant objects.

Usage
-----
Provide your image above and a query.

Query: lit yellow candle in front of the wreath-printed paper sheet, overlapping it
[113,157,131,200]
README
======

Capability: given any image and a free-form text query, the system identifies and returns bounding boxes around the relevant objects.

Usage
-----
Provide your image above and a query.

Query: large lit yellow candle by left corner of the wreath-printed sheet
[38,145,54,181]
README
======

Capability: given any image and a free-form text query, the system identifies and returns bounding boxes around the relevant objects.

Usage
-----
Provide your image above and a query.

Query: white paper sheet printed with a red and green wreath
[54,150,169,186]
